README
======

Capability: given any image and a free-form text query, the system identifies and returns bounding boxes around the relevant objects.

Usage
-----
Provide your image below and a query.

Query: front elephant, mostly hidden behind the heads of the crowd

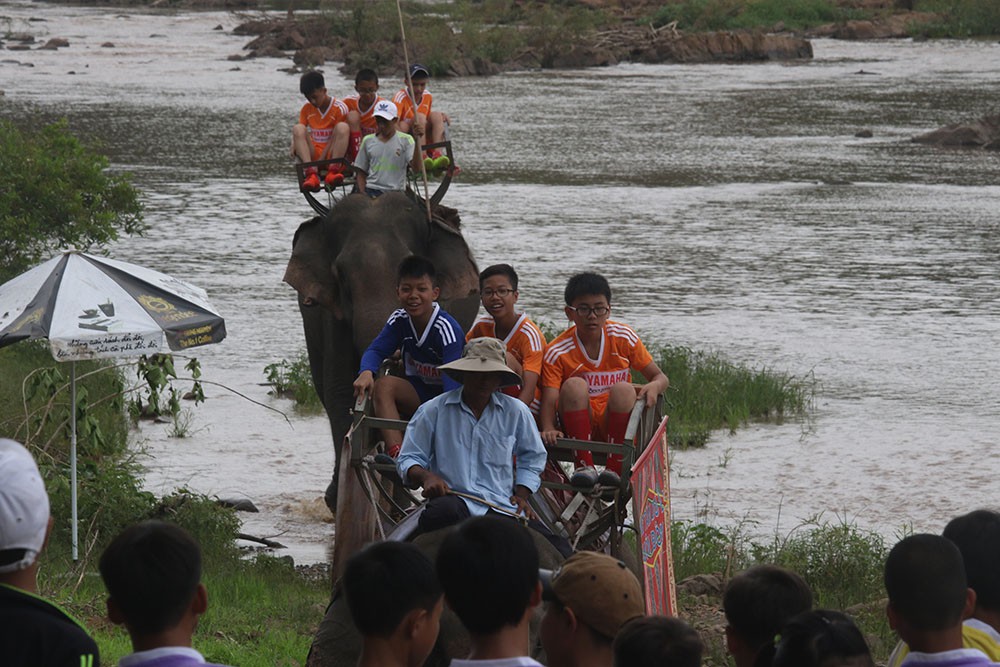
[306,528,564,667]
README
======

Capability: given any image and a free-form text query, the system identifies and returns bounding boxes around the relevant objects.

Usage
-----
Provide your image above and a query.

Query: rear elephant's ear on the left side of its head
[283,217,344,319]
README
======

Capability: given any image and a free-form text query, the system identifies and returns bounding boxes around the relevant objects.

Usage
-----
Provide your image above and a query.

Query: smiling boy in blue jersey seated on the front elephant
[354,256,465,458]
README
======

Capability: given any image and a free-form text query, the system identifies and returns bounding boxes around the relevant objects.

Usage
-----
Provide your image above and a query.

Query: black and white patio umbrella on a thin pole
[0,251,226,560]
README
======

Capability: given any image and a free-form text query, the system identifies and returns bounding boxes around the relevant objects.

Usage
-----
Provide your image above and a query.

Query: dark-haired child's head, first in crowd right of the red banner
[722,565,812,667]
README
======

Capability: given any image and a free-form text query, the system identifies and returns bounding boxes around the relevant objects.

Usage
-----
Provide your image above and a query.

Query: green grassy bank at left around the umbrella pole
[0,343,329,667]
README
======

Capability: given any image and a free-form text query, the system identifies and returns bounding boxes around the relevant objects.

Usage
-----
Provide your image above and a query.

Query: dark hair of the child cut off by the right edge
[942,510,1000,611]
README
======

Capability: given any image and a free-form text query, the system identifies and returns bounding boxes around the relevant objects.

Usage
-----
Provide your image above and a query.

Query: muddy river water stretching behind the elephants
[0,3,1000,562]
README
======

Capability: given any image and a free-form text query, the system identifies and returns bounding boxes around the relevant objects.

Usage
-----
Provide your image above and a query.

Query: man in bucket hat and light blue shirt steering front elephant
[396,338,568,548]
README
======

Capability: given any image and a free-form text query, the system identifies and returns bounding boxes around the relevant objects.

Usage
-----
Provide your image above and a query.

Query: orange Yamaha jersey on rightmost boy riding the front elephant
[541,320,653,410]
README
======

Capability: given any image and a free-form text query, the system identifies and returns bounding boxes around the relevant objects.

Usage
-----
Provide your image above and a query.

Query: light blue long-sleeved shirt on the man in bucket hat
[396,387,546,516]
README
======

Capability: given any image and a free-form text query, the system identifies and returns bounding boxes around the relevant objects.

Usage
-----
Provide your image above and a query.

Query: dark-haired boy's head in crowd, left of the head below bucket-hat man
[343,542,444,667]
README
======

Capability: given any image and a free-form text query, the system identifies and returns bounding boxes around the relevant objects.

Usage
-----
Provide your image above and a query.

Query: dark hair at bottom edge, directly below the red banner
[613,616,705,667]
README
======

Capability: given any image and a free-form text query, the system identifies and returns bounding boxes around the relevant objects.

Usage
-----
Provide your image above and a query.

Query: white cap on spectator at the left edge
[0,438,49,573]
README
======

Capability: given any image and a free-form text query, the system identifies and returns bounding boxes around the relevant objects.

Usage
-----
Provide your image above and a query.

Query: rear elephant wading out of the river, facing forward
[284,192,479,516]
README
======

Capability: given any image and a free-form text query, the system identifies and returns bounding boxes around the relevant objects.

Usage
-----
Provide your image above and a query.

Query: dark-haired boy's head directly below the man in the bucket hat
[435,516,542,667]
